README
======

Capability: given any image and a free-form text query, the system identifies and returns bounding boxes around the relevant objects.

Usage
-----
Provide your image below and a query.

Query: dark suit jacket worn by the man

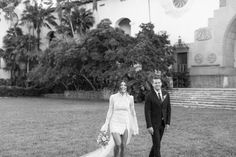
[145,89,171,128]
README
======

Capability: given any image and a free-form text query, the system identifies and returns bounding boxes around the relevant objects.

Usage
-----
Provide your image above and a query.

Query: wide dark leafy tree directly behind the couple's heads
[81,20,174,100]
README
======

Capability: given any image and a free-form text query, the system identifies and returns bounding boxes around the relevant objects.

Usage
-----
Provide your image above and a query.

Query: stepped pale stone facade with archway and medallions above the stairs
[189,0,236,88]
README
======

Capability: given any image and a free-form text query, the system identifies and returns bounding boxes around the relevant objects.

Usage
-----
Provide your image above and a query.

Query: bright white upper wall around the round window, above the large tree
[86,0,219,44]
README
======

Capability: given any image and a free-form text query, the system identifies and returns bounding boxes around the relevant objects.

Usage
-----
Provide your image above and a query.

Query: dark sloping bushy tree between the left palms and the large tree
[29,39,94,90]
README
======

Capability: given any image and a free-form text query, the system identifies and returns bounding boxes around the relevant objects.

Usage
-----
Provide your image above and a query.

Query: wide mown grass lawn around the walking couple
[0,98,236,157]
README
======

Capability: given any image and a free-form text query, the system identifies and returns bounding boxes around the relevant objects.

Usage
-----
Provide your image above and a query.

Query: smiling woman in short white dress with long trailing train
[82,80,138,157]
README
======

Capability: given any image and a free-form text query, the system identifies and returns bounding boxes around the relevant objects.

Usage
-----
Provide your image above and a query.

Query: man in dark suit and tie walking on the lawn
[145,76,171,157]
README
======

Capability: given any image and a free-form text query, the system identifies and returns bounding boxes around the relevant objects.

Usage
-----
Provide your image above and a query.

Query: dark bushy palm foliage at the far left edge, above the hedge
[2,27,36,86]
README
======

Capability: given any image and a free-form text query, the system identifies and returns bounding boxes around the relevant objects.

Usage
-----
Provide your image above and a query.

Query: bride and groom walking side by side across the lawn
[83,76,171,157]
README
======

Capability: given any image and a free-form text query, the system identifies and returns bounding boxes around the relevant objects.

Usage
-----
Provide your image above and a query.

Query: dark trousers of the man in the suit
[149,120,165,157]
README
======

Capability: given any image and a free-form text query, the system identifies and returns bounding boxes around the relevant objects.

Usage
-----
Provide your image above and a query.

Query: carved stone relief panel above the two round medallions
[195,28,212,41]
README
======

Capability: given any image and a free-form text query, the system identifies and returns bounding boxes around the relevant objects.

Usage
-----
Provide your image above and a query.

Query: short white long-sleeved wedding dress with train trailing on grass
[81,92,138,157]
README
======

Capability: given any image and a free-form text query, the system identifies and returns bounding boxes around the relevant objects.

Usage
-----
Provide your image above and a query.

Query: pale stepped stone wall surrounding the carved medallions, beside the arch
[190,0,236,67]
